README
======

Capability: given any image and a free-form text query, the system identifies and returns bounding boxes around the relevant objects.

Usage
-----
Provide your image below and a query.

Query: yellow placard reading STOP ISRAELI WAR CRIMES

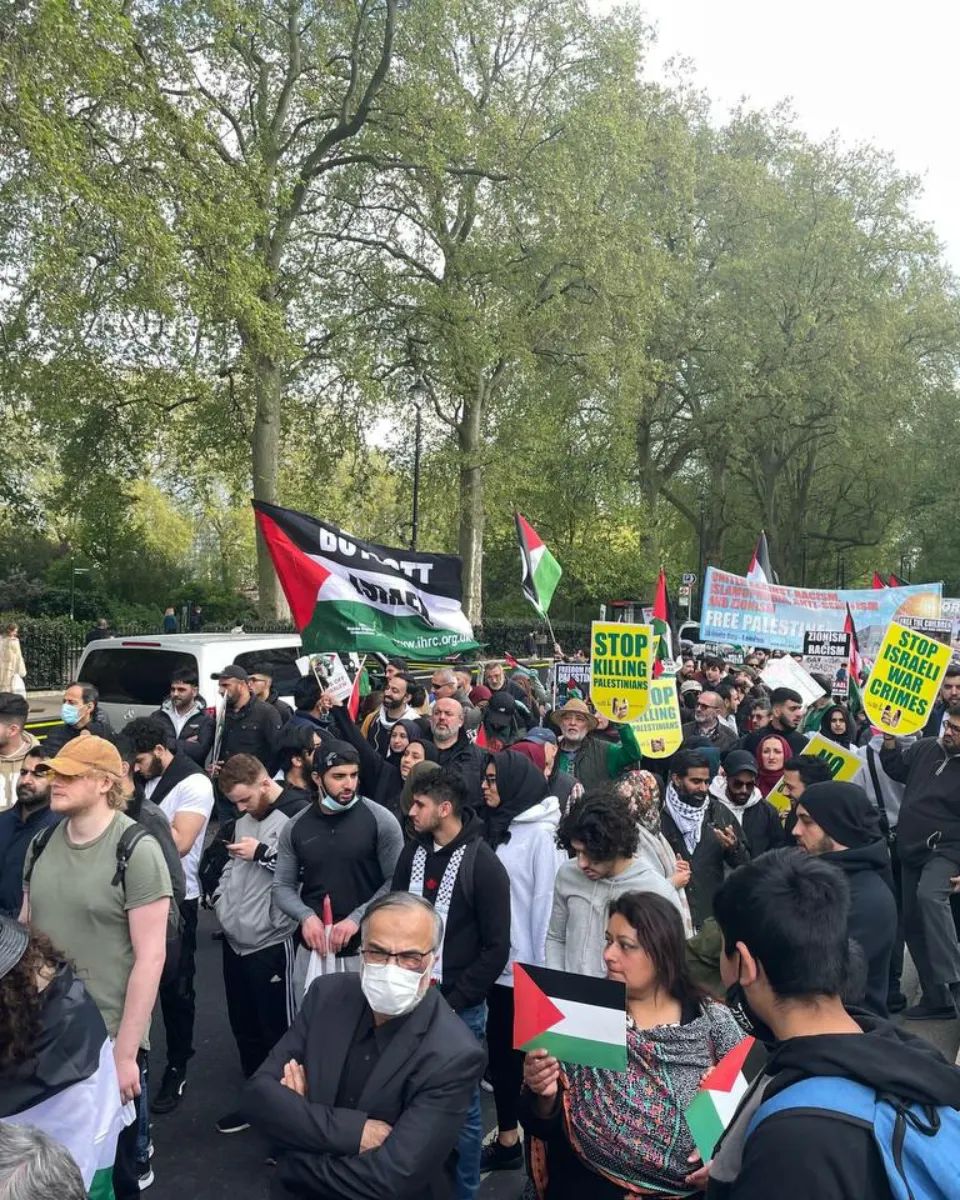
[863,620,950,734]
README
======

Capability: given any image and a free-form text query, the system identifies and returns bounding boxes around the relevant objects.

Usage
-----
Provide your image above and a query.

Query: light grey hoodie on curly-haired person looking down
[546,858,683,978]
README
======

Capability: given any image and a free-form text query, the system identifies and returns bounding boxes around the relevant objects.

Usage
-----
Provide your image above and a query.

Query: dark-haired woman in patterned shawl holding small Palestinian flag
[520,892,745,1200]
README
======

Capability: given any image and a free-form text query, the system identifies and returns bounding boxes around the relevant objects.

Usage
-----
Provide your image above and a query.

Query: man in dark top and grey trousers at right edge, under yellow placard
[880,707,960,1020]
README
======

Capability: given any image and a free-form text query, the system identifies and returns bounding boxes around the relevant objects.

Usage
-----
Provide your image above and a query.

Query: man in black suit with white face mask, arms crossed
[242,892,486,1200]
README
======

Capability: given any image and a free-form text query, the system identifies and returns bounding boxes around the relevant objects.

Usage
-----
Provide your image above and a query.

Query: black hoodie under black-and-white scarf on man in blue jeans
[392,810,510,1012]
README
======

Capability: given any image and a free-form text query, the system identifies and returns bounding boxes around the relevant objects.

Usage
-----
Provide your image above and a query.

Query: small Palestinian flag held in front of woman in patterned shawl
[514,962,626,1070]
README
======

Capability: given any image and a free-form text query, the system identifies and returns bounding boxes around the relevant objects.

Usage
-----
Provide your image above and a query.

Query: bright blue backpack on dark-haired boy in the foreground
[746,1075,960,1200]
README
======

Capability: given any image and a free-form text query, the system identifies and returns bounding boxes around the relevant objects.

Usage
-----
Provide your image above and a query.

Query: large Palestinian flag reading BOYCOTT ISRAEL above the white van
[253,500,479,660]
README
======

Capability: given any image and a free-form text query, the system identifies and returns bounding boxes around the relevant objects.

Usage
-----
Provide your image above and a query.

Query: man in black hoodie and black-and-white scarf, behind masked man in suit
[394,772,510,1198]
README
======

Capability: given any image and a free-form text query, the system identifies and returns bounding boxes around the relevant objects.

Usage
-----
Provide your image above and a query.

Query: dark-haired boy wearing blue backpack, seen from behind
[707,850,960,1200]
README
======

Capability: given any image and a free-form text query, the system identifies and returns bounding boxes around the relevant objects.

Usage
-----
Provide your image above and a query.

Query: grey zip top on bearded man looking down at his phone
[214,806,296,956]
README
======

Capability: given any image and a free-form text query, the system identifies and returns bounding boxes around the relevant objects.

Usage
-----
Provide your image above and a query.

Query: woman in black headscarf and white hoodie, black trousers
[480,748,564,1171]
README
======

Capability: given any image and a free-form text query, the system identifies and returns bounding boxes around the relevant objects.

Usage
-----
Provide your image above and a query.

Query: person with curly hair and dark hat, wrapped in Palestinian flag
[0,917,131,1195]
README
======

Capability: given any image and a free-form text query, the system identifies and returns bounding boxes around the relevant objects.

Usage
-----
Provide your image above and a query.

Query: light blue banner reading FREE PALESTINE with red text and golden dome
[700,566,943,658]
